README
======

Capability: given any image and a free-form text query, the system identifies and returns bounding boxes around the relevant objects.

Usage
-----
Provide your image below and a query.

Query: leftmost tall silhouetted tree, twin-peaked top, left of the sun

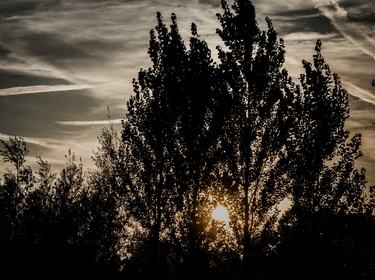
[122,13,186,277]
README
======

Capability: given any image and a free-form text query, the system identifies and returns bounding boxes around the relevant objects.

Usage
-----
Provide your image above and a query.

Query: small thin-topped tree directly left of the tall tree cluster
[81,118,127,265]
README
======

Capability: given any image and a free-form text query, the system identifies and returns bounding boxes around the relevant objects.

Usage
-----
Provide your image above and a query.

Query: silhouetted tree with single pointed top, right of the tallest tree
[291,40,352,211]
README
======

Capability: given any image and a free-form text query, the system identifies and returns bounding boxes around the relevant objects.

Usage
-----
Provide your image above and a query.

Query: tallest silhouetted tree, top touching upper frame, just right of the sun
[217,0,296,278]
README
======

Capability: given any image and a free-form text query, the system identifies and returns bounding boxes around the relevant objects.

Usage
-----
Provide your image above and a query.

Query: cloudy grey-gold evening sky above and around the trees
[0,0,375,185]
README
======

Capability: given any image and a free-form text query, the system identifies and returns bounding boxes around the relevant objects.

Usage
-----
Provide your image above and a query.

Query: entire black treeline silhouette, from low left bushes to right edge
[0,0,375,279]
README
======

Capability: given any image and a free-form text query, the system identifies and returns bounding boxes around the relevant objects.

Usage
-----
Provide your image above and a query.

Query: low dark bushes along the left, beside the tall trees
[0,134,126,279]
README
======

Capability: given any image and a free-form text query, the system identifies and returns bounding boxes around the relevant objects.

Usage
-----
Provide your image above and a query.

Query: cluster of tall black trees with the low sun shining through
[122,0,375,278]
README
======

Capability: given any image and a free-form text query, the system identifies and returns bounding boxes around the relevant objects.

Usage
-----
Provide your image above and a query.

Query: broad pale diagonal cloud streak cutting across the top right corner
[313,0,375,59]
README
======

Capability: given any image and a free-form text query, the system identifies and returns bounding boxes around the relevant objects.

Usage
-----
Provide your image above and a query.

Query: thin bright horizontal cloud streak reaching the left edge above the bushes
[0,85,91,96]
